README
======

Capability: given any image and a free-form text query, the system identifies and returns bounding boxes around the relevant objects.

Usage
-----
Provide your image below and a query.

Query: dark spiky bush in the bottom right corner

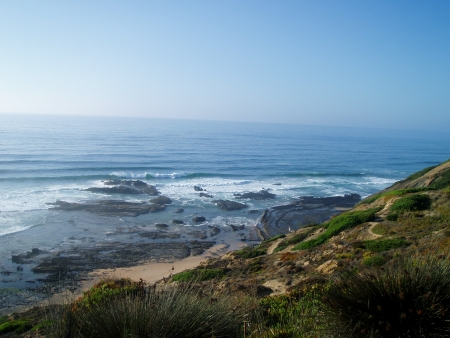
[324,256,450,338]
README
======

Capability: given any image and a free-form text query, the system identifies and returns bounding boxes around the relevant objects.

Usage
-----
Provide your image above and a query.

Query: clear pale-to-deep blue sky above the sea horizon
[0,0,450,131]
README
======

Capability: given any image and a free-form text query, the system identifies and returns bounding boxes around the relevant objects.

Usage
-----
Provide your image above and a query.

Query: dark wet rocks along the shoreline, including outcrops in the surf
[0,180,360,314]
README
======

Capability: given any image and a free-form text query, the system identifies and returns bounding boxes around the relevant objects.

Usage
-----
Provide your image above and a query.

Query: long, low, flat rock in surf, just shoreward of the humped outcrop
[48,200,166,217]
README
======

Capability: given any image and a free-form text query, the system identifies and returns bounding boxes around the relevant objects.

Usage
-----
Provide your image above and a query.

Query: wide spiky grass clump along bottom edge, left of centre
[52,283,249,338]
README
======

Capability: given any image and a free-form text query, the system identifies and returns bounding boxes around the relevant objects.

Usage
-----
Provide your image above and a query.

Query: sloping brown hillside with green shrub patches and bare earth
[185,161,450,296]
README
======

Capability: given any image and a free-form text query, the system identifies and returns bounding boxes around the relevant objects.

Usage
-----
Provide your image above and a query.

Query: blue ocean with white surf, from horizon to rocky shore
[0,115,450,260]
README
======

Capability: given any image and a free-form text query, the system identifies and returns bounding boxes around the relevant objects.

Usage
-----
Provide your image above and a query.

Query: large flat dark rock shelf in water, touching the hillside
[257,194,361,238]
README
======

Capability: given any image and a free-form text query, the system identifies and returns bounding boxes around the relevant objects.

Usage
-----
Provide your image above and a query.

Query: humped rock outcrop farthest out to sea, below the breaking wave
[85,180,160,196]
